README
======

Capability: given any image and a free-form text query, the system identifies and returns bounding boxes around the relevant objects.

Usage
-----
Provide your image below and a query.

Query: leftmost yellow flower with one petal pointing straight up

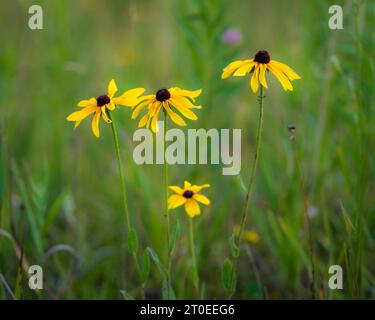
[66,79,145,138]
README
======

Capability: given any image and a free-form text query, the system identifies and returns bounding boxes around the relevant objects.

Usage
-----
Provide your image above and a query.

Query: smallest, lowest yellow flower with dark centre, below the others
[168,181,210,218]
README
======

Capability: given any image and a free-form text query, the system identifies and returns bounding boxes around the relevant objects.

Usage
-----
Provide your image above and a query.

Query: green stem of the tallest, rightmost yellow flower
[237,85,264,252]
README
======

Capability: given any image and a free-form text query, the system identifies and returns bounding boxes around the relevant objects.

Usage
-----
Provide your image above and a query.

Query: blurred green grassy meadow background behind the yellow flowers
[0,0,375,299]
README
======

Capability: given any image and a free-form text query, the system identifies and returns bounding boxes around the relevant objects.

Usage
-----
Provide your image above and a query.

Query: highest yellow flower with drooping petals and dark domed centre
[221,50,301,93]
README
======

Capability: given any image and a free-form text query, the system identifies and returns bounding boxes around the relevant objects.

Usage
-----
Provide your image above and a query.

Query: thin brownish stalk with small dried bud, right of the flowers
[289,126,316,300]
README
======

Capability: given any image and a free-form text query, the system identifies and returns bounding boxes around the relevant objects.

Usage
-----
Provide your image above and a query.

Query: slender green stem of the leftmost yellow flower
[108,112,145,298]
